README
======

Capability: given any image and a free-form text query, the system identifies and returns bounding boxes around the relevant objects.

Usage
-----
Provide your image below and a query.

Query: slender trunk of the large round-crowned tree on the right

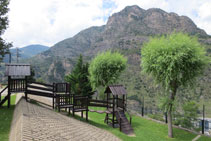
[168,83,177,138]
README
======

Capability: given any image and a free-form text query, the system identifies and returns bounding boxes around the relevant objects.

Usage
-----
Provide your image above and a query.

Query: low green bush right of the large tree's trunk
[176,101,199,128]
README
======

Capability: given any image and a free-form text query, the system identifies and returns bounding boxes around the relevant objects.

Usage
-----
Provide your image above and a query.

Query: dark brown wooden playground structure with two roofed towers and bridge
[0,64,133,134]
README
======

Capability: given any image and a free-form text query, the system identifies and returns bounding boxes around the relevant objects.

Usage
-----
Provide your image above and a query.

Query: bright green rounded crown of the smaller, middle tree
[89,51,127,89]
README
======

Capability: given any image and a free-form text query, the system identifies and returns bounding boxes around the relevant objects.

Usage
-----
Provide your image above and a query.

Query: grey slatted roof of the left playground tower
[5,64,31,76]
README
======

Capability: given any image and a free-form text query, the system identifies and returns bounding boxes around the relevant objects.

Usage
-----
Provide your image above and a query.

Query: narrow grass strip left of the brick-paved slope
[0,95,16,141]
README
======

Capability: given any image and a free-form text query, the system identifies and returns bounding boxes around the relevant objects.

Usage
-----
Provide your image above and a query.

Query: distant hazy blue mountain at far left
[4,44,49,62]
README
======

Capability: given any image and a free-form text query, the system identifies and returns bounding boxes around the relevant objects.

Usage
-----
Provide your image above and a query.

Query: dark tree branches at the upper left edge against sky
[0,0,12,62]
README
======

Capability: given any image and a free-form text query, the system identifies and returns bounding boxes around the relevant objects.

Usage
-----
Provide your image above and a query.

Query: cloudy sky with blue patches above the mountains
[3,0,211,47]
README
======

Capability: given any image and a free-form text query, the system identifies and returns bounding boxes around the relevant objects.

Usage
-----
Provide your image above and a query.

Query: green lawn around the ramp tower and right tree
[70,108,211,141]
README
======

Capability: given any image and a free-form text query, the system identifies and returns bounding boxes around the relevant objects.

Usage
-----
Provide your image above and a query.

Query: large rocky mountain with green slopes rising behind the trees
[27,5,211,111]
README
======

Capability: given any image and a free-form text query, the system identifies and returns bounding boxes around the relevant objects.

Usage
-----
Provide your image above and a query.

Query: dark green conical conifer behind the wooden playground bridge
[65,55,93,96]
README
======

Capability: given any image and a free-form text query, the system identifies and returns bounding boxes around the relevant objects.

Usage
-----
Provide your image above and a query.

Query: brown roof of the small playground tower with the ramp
[105,85,127,95]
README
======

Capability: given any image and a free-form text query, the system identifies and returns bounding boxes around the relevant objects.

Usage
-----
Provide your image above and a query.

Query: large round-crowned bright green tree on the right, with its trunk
[141,33,208,137]
